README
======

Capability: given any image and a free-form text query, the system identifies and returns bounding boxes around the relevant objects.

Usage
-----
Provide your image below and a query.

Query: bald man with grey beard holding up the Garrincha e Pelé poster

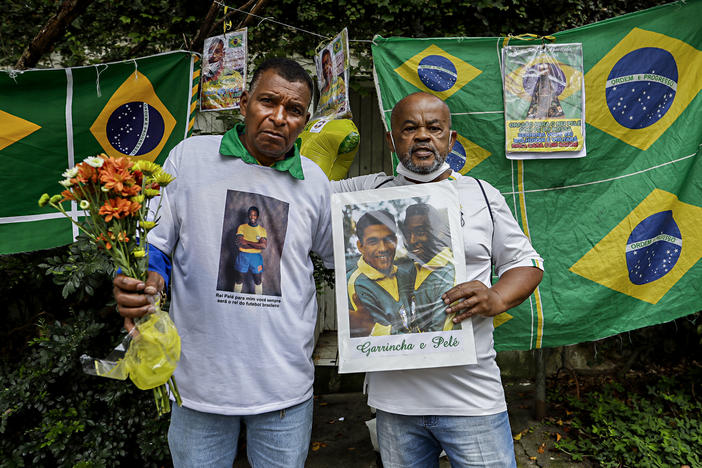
[332,93,543,468]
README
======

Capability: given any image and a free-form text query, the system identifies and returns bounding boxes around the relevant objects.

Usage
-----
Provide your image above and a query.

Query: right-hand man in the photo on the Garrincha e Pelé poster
[401,203,456,332]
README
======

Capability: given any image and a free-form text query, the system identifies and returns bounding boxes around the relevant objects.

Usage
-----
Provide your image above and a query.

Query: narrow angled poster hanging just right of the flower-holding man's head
[313,28,351,119]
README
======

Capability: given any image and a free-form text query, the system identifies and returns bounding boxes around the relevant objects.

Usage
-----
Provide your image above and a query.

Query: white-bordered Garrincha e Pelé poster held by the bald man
[332,182,476,373]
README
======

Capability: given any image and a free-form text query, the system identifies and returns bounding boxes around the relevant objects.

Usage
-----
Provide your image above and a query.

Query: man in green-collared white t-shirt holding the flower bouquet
[114,58,333,468]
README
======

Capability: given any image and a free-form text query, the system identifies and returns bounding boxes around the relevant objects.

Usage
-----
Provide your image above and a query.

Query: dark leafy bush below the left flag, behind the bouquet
[0,239,170,467]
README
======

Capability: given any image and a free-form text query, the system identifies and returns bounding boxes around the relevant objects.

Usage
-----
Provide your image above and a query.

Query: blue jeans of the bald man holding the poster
[376,410,517,468]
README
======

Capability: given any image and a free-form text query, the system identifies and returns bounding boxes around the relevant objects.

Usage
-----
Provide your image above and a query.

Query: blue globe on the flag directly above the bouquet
[106,102,165,156]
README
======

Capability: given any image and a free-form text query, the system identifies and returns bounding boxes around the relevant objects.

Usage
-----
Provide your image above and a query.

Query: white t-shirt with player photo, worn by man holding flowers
[149,136,333,415]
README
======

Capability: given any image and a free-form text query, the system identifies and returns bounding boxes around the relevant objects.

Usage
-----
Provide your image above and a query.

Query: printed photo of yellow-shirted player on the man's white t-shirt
[217,190,289,296]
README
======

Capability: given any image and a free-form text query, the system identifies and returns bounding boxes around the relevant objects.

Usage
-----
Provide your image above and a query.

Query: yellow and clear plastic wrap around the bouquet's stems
[80,309,180,390]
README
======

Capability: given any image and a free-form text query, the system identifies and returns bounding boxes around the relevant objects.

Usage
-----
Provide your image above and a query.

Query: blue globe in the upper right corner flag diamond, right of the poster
[605,47,678,129]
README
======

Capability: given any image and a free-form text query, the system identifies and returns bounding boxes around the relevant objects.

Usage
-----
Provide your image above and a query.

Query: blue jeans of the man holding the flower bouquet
[168,398,313,468]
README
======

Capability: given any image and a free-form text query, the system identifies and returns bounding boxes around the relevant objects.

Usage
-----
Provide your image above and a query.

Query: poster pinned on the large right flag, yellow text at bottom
[502,44,586,159]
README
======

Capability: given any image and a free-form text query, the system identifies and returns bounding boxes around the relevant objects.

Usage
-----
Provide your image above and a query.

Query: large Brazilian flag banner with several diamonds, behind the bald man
[373,0,702,350]
